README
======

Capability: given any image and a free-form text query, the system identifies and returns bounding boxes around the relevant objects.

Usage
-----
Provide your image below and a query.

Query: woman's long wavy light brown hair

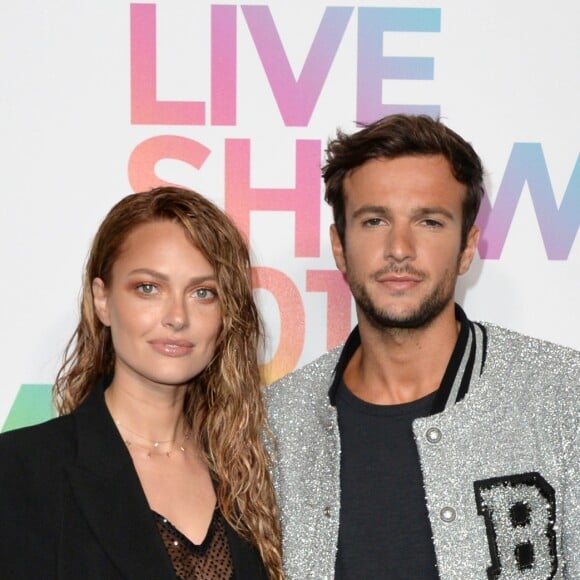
[54,187,283,579]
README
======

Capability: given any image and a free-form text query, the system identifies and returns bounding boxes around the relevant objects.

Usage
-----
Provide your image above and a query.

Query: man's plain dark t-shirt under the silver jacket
[335,381,439,580]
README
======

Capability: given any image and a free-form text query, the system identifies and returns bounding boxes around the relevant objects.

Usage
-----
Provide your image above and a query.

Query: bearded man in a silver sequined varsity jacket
[266,115,580,580]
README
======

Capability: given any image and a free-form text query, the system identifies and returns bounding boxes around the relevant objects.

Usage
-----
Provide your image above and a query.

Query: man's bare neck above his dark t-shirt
[343,308,459,405]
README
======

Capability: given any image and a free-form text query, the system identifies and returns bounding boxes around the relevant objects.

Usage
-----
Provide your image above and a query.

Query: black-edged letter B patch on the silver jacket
[473,473,558,580]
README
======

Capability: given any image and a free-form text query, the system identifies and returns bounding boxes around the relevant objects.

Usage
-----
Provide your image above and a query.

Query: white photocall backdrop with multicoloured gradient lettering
[0,0,580,430]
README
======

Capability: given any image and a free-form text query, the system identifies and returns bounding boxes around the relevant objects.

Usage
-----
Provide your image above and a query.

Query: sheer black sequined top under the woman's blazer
[153,510,233,580]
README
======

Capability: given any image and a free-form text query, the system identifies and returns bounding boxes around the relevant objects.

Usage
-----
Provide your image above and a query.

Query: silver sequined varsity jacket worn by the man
[265,324,580,580]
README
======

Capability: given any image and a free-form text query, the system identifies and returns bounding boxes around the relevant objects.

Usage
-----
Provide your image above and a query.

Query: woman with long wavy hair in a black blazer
[0,187,282,580]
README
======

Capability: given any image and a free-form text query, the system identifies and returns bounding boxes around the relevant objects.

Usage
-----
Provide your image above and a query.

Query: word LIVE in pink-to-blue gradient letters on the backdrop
[131,4,441,127]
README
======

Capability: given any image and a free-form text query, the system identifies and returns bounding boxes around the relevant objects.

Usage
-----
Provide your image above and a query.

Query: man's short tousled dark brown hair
[322,114,484,249]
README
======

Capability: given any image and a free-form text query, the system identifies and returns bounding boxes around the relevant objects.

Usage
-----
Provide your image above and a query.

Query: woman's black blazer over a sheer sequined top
[0,385,267,580]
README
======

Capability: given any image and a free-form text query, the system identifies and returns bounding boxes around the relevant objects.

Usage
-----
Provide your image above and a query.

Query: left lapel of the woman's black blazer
[69,385,175,580]
